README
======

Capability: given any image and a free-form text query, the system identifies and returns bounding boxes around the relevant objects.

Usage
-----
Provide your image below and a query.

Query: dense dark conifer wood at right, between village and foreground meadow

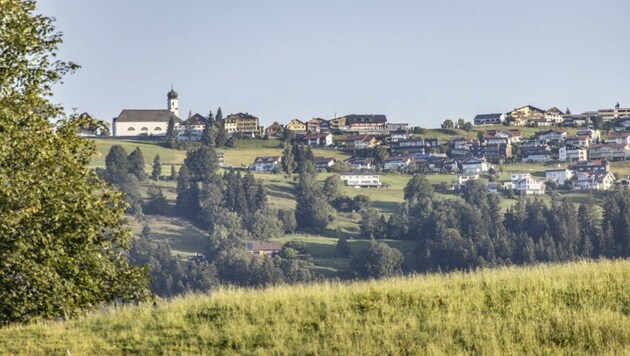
[361,175,630,271]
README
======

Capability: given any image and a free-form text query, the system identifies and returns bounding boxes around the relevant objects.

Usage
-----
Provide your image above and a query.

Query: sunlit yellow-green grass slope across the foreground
[0,261,630,354]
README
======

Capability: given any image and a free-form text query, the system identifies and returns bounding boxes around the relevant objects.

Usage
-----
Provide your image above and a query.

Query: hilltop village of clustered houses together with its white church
[96,89,630,194]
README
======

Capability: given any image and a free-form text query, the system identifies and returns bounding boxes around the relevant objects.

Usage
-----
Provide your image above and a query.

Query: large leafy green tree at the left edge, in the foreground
[0,0,148,325]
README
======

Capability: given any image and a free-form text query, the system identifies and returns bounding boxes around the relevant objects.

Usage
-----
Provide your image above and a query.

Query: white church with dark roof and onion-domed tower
[112,88,182,136]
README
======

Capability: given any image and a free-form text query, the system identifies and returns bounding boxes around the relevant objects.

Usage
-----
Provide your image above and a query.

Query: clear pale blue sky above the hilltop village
[38,0,630,127]
